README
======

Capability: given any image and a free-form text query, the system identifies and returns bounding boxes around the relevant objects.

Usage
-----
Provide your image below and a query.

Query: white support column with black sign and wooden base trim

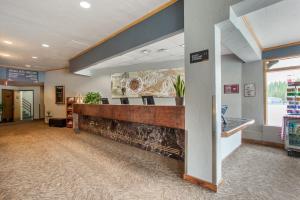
[184,0,241,190]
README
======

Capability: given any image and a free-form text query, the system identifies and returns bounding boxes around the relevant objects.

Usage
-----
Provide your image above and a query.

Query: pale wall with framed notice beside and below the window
[242,61,283,143]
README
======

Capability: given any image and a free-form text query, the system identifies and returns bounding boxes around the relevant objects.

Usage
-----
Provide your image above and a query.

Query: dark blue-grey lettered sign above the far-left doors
[7,69,39,83]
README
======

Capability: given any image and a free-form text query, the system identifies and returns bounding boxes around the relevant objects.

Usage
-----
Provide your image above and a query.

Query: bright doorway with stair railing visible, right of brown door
[20,90,34,120]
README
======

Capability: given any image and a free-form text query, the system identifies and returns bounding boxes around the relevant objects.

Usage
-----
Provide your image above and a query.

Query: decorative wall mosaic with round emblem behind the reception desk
[111,68,184,98]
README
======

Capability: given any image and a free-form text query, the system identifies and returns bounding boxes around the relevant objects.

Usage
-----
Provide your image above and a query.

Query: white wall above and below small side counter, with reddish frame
[221,55,242,159]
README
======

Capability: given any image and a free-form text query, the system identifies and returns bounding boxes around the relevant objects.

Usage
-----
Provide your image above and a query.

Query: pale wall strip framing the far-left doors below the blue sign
[0,85,42,119]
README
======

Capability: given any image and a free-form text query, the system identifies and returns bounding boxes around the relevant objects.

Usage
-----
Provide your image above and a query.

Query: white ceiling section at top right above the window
[247,0,300,48]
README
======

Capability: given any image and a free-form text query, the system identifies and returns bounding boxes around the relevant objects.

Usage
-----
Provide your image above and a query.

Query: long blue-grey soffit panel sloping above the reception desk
[70,0,184,72]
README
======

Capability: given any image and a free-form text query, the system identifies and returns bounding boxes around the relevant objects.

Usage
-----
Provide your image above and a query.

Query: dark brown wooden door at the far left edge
[2,89,14,122]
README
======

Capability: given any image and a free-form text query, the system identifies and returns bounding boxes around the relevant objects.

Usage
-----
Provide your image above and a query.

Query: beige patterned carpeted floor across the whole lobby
[0,122,300,200]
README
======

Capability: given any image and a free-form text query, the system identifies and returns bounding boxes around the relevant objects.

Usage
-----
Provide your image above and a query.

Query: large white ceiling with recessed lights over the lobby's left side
[0,0,169,70]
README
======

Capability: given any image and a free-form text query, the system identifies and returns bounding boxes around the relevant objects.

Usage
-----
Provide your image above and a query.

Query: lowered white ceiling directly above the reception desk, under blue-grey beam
[77,33,232,76]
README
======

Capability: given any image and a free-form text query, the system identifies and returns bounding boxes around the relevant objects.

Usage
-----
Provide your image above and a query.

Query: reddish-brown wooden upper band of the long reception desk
[73,104,185,129]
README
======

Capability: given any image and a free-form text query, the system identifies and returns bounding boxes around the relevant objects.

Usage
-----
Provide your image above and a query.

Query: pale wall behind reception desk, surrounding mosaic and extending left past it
[44,60,184,117]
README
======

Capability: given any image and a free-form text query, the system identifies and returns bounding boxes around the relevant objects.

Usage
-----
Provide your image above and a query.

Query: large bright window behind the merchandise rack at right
[265,58,300,127]
